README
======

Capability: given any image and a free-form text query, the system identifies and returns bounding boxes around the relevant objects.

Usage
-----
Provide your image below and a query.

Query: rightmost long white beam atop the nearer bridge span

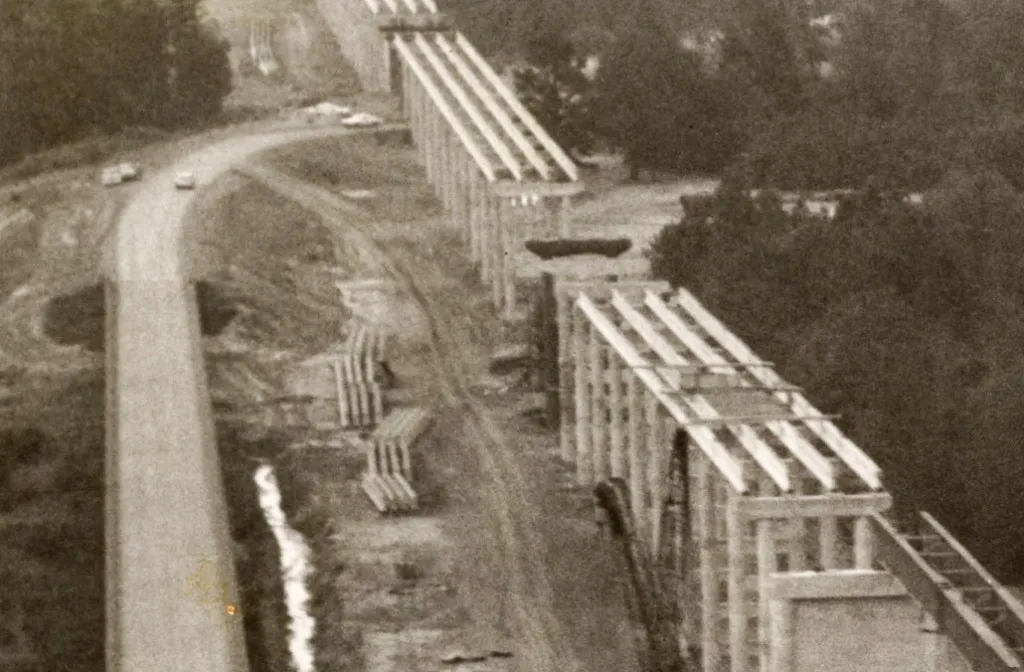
[677,288,882,490]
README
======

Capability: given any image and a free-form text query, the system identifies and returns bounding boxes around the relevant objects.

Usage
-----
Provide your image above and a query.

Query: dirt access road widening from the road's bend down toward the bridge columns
[240,166,636,672]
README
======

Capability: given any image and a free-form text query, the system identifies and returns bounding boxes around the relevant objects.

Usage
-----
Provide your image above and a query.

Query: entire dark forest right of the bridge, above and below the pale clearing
[495,0,1024,582]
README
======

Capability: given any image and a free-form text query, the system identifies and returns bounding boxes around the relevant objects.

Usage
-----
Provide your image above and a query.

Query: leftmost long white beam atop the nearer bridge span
[575,295,746,493]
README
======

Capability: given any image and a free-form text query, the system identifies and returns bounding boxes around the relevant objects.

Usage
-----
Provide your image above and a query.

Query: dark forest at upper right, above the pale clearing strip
[505,0,1024,188]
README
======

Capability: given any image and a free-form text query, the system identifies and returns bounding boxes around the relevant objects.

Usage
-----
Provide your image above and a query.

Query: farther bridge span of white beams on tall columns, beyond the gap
[393,33,584,313]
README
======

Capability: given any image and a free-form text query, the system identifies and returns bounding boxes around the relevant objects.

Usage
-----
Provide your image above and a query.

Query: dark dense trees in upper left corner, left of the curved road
[0,0,231,164]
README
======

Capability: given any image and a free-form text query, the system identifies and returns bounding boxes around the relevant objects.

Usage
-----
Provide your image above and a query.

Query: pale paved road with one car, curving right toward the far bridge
[104,128,399,672]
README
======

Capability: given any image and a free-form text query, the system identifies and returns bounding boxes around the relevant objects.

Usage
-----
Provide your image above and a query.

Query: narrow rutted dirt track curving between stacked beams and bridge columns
[242,166,635,672]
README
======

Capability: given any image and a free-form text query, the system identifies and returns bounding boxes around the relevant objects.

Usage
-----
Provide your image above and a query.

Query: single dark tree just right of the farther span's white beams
[515,29,595,160]
